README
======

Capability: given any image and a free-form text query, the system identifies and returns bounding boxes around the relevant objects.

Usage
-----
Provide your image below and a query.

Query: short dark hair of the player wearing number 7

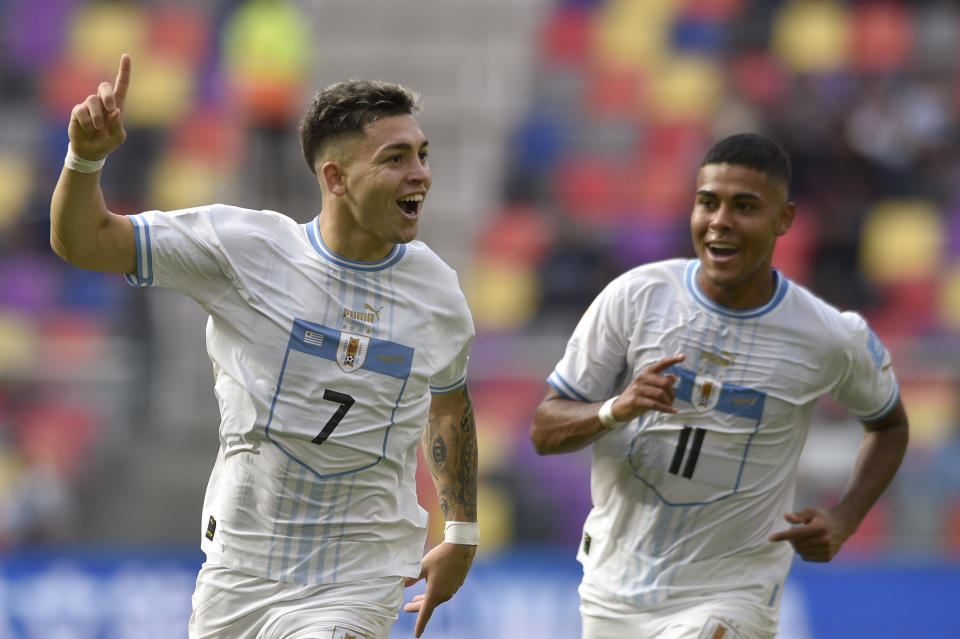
[299,80,420,174]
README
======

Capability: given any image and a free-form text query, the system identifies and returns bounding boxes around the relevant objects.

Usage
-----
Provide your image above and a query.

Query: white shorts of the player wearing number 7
[189,562,404,639]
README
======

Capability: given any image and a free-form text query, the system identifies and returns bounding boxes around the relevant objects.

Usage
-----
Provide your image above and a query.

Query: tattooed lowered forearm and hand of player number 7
[403,386,477,637]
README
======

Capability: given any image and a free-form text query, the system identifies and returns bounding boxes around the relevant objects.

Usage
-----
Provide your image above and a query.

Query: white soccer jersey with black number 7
[127,204,474,584]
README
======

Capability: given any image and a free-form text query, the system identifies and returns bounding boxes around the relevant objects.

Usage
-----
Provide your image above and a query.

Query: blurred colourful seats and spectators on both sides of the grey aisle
[0,0,960,555]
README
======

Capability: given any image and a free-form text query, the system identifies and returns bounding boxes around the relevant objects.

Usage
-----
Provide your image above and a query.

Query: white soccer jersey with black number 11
[549,260,898,607]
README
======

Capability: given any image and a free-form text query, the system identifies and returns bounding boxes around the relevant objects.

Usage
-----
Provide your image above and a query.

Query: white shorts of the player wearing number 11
[580,584,779,639]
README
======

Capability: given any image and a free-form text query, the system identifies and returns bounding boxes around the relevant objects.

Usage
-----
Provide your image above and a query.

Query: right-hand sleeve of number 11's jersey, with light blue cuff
[830,312,900,422]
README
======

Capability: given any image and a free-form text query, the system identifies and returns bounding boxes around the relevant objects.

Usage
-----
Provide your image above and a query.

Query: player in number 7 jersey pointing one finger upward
[50,55,478,639]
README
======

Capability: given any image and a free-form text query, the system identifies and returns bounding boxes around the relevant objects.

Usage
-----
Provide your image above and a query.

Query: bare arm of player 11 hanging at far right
[770,401,909,561]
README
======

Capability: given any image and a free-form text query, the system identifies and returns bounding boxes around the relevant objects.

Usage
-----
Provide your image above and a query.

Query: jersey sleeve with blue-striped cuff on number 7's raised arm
[126,206,233,303]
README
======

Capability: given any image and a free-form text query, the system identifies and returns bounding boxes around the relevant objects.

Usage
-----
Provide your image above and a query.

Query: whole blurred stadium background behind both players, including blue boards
[0,0,960,639]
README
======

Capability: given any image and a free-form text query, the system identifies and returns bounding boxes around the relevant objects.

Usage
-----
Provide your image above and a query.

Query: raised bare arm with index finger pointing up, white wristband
[50,54,137,273]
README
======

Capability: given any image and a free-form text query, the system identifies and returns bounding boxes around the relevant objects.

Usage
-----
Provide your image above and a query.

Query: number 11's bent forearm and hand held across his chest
[530,355,684,455]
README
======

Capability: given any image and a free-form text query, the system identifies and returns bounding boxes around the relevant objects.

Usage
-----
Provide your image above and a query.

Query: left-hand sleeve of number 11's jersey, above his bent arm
[547,278,629,402]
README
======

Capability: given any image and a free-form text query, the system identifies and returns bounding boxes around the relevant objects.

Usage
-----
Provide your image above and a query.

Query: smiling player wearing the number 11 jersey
[530,134,908,639]
